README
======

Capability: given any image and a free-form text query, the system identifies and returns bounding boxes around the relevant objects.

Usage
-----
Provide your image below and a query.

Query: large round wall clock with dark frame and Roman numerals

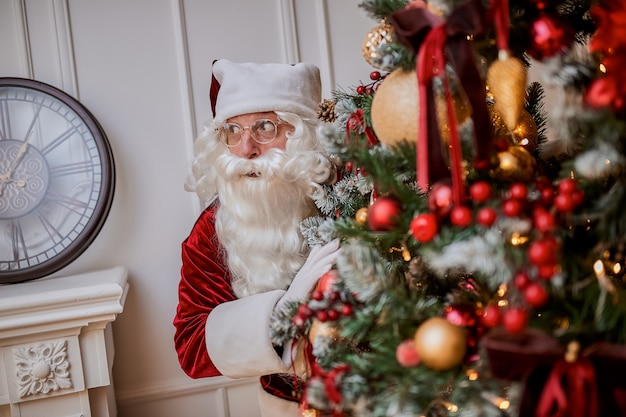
[0,78,115,284]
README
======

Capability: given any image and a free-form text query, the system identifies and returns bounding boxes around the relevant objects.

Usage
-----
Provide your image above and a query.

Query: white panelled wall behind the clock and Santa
[0,0,377,417]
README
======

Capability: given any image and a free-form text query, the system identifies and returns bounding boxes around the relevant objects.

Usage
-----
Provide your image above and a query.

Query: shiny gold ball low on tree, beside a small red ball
[414,317,467,371]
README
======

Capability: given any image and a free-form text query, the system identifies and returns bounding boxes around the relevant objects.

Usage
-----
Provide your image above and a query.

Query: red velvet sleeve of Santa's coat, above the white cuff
[174,205,236,378]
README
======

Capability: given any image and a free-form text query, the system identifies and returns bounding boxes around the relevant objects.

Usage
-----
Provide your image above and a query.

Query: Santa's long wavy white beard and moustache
[215,149,317,298]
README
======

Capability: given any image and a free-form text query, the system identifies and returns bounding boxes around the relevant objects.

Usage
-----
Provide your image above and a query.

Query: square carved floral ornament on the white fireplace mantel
[14,340,73,398]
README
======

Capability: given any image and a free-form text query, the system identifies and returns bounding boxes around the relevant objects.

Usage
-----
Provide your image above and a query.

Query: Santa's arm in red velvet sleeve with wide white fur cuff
[174,206,288,378]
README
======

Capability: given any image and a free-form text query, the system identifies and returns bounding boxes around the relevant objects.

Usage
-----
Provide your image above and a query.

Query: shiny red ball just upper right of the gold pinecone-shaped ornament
[526,13,574,61]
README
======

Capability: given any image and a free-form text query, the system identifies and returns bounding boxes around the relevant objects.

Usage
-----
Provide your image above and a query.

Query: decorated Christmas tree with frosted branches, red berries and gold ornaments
[271,0,626,417]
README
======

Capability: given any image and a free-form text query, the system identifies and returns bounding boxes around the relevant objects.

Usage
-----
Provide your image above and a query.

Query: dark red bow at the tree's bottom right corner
[481,330,626,417]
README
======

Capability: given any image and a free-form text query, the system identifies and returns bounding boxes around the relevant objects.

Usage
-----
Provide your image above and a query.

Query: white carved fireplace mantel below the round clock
[0,267,128,417]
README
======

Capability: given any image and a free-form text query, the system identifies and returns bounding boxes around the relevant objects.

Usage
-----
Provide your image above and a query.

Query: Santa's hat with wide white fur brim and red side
[209,59,321,122]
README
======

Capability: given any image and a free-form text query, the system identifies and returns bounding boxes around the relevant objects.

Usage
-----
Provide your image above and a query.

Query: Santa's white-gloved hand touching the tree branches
[276,239,339,308]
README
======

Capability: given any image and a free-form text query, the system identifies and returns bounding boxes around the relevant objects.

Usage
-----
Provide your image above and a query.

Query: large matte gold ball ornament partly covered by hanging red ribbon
[371,68,419,146]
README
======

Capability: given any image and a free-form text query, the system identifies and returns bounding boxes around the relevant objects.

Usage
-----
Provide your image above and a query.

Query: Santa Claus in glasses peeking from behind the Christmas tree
[174,60,338,417]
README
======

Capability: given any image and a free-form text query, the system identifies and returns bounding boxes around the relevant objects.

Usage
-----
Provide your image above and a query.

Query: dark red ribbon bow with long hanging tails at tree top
[391,0,492,204]
